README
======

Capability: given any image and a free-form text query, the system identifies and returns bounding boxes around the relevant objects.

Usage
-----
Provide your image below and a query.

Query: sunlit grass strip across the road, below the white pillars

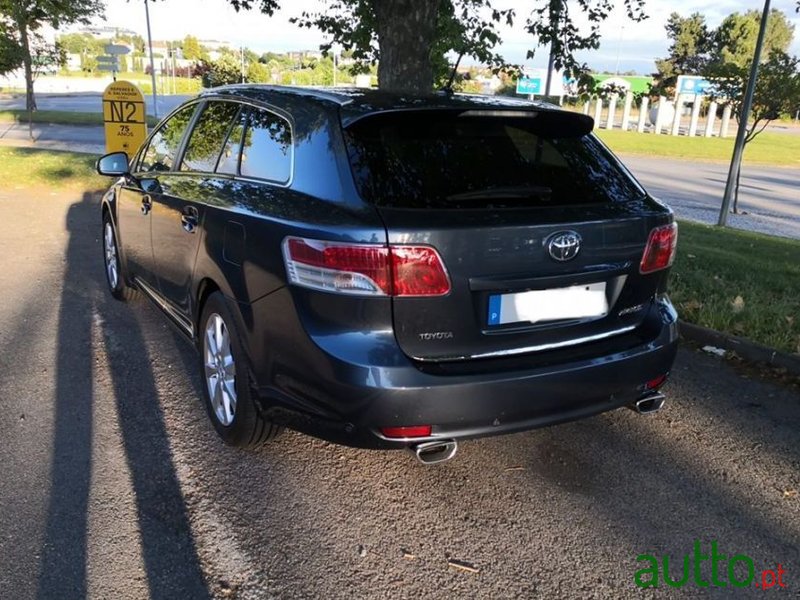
[595,129,800,167]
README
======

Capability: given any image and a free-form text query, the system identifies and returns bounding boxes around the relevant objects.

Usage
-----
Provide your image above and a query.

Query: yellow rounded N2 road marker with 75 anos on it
[103,81,147,156]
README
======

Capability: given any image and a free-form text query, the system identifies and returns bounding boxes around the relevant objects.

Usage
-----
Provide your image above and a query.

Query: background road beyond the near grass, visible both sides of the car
[0,124,800,239]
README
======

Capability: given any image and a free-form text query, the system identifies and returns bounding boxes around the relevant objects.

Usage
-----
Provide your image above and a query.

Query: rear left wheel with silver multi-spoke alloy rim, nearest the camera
[198,292,281,447]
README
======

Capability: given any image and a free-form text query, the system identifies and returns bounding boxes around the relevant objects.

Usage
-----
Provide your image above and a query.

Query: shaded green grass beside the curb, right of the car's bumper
[670,221,800,354]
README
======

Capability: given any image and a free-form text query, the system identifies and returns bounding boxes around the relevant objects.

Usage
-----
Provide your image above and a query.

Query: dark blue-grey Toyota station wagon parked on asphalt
[98,85,677,463]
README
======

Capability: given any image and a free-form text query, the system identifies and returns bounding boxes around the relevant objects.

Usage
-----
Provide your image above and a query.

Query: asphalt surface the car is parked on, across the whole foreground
[0,190,800,600]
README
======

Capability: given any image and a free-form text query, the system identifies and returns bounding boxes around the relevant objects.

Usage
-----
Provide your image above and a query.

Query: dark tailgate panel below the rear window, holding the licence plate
[380,209,663,359]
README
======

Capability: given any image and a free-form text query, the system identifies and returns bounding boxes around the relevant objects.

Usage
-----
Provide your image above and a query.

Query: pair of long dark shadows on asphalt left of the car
[38,194,210,600]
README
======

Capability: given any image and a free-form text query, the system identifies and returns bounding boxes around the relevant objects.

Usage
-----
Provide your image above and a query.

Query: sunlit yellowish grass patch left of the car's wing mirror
[0,146,105,191]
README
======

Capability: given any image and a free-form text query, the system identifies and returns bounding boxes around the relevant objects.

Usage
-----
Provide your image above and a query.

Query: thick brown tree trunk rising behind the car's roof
[372,0,441,94]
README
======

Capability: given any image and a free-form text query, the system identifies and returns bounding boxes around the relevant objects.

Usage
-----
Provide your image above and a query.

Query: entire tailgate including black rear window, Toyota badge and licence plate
[347,106,672,361]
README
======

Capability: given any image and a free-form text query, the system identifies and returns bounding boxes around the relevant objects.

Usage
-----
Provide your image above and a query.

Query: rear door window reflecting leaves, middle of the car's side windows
[181,102,239,173]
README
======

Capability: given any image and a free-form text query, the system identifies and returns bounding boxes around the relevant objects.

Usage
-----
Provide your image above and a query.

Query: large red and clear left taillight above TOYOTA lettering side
[283,237,450,296]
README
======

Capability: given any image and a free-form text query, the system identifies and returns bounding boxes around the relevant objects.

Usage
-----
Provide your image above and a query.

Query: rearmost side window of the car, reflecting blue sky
[239,109,292,183]
